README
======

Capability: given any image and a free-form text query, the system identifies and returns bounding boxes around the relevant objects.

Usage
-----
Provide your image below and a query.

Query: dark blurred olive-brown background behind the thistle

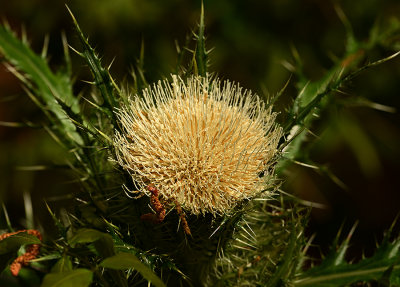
[0,0,400,256]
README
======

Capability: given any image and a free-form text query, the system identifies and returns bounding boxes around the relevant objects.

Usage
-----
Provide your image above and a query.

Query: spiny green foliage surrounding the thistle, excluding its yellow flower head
[0,6,400,287]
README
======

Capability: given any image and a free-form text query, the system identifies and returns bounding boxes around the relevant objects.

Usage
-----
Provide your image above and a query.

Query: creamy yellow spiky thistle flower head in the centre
[115,76,281,215]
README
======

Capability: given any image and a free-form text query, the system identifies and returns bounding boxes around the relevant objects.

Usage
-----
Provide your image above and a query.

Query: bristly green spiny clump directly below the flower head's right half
[207,196,307,286]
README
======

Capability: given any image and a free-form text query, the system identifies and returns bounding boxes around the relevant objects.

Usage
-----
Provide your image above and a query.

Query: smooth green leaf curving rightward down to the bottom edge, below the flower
[100,253,166,287]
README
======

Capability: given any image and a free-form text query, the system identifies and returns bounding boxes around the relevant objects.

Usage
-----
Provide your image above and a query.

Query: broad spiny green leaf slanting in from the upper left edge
[0,26,82,144]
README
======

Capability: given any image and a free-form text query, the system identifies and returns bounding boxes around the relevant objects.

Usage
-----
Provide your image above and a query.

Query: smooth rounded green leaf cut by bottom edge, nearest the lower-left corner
[41,268,93,287]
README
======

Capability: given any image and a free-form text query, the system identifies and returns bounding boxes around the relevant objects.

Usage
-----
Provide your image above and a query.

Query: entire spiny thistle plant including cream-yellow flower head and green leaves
[0,2,400,287]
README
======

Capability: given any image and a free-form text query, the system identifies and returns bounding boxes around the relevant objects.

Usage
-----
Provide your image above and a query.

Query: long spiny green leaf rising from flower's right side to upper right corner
[278,16,400,176]
